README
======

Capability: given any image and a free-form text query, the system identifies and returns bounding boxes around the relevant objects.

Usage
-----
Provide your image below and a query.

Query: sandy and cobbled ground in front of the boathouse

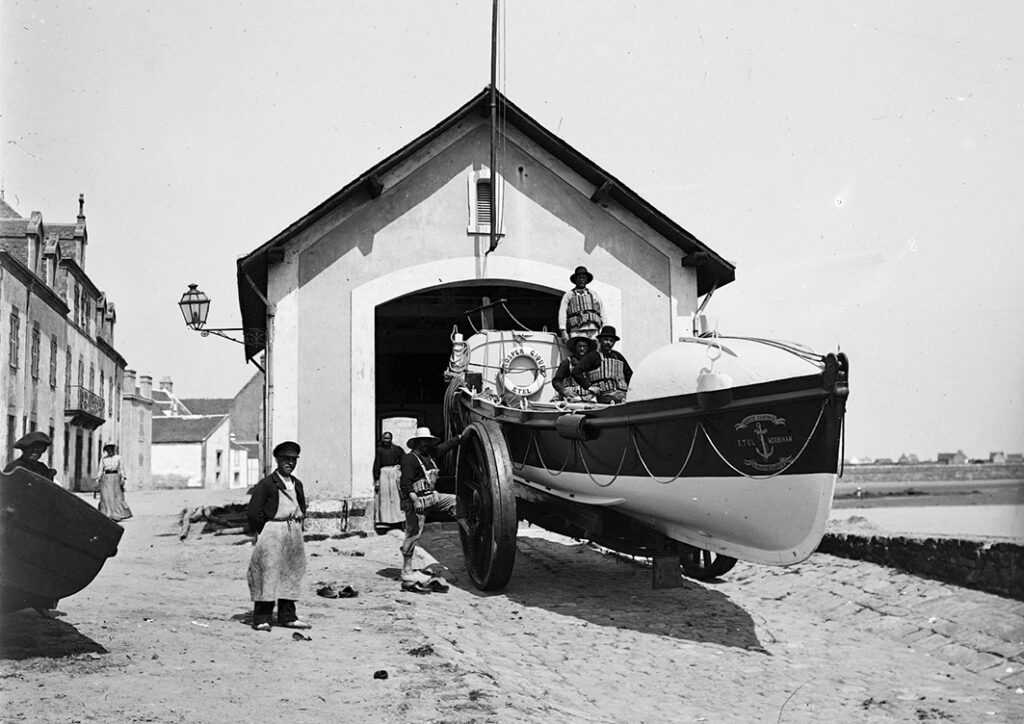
[0,517,1024,724]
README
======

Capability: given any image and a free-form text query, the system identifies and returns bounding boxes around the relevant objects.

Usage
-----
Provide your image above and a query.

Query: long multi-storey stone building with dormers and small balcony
[0,196,126,489]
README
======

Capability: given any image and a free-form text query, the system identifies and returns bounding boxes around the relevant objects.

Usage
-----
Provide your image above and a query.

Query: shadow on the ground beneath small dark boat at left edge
[0,608,110,659]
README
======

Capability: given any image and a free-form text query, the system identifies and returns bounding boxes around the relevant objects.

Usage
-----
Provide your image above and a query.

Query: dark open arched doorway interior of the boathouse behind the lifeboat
[375,284,561,442]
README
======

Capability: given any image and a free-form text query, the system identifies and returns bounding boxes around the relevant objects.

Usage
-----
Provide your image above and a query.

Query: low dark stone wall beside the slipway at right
[818,533,1024,601]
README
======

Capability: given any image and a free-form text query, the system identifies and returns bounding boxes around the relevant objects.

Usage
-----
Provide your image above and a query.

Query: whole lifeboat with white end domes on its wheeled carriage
[444,303,848,590]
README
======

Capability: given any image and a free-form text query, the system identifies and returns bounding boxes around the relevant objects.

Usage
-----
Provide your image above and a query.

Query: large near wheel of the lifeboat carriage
[456,420,518,591]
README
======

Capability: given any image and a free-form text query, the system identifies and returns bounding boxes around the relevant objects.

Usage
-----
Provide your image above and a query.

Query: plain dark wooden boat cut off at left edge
[0,468,124,612]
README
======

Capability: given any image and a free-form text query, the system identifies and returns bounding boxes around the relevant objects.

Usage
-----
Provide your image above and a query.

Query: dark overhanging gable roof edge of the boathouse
[237,86,735,359]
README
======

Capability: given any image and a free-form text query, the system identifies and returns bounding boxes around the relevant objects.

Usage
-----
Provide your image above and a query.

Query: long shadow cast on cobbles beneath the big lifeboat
[422,531,770,655]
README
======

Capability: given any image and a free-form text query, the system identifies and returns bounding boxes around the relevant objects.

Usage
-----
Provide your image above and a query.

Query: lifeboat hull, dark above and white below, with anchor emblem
[458,355,847,565]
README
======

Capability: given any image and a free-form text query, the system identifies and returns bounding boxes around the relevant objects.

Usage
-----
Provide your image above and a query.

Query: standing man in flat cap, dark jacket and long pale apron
[247,440,310,631]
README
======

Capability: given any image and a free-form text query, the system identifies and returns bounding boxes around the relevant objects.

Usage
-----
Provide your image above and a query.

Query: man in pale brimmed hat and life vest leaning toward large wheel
[398,427,465,592]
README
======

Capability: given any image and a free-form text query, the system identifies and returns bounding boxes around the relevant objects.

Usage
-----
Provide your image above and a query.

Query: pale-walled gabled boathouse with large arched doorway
[238,88,734,509]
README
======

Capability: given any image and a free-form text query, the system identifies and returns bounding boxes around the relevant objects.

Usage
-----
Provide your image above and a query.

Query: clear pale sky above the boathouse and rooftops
[0,0,1024,459]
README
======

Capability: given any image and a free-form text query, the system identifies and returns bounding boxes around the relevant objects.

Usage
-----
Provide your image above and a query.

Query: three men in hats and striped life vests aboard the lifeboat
[551,266,633,403]
